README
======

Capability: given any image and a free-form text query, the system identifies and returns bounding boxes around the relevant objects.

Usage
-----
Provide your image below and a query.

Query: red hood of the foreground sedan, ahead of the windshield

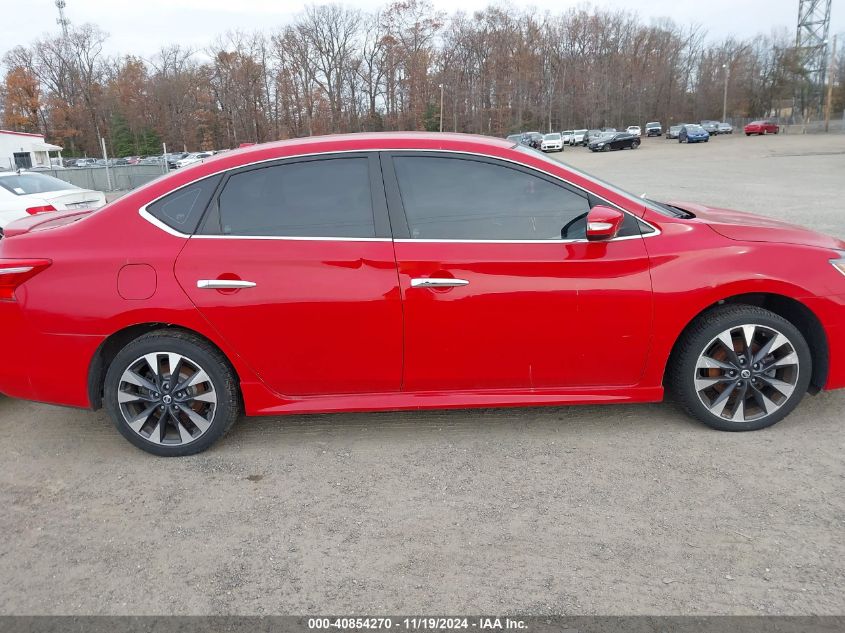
[670,202,845,250]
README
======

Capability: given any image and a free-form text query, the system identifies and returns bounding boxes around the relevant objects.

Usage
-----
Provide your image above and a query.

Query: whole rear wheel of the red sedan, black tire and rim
[103,330,241,457]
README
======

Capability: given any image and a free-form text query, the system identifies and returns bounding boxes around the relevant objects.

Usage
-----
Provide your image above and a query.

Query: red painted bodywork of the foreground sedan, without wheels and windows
[0,133,845,415]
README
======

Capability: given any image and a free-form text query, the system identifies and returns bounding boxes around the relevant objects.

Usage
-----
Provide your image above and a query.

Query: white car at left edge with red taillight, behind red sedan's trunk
[0,171,106,228]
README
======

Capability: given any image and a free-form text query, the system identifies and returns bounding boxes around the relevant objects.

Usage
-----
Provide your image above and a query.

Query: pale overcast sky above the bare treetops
[0,0,845,58]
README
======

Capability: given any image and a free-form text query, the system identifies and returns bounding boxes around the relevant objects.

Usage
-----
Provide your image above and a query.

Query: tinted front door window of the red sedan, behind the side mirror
[393,156,589,240]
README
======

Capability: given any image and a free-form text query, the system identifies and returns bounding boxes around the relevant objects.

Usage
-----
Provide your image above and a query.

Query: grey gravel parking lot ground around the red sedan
[0,134,845,615]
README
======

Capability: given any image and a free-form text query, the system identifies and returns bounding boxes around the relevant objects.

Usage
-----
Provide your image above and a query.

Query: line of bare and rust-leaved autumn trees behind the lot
[0,0,845,156]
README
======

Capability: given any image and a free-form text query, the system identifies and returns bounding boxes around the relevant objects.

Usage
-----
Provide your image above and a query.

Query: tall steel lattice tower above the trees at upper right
[796,0,831,114]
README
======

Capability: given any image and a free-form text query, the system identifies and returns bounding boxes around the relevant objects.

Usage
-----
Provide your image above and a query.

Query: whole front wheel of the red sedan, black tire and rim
[666,305,813,431]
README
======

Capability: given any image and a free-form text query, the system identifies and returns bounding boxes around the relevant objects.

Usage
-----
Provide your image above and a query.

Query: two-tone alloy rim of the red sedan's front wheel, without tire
[695,324,800,422]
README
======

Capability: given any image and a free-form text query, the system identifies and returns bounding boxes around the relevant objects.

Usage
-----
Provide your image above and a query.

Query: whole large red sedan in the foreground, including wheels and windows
[0,133,845,455]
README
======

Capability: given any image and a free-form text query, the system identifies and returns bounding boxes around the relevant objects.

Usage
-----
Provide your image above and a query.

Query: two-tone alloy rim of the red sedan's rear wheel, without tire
[117,352,217,446]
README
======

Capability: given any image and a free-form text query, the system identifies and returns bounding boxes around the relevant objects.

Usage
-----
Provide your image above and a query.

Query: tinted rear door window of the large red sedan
[219,158,375,237]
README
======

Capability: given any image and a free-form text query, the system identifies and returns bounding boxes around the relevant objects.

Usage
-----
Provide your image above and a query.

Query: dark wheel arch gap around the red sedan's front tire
[662,292,830,394]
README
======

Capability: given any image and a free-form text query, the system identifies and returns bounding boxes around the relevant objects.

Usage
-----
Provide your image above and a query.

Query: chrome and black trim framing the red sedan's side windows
[138,148,662,244]
